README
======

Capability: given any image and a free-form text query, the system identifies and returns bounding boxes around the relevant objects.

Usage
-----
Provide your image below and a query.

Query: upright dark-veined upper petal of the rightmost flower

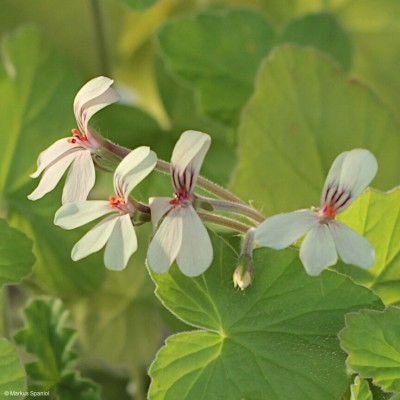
[321,149,378,213]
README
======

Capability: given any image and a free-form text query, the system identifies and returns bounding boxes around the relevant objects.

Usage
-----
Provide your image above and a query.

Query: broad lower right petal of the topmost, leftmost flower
[62,150,96,204]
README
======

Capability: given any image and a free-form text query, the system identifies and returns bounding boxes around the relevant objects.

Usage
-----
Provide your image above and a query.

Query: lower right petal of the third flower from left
[176,206,213,276]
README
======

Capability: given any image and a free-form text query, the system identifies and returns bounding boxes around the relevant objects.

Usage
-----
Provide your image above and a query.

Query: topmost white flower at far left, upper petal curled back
[28,76,119,204]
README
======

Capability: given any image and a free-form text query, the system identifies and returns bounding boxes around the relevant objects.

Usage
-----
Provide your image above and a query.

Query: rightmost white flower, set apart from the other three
[255,149,378,275]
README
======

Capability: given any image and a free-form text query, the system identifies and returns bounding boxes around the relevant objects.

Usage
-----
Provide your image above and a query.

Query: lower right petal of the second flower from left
[104,214,137,271]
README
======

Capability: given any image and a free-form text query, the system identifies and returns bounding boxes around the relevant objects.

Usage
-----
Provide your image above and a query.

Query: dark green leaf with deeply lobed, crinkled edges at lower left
[14,298,100,400]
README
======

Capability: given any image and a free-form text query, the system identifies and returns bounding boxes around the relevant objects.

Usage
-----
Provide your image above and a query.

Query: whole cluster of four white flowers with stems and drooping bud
[28,77,378,289]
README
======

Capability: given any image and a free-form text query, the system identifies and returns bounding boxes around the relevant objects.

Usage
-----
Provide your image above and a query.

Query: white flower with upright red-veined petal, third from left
[147,131,213,276]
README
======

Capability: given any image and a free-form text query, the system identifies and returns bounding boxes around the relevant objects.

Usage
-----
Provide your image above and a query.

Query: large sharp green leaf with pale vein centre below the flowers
[149,235,382,400]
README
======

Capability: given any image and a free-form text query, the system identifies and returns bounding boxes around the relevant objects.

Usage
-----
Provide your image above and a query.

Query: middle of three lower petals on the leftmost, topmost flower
[28,151,80,200]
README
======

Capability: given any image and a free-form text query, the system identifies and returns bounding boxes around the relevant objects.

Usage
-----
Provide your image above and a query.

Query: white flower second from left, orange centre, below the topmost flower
[54,147,157,270]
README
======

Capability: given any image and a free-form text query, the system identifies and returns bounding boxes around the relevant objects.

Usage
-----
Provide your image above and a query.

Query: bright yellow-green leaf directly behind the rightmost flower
[336,188,400,305]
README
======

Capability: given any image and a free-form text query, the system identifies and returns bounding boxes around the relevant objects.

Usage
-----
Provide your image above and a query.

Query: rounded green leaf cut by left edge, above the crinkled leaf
[0,219,35,287]
